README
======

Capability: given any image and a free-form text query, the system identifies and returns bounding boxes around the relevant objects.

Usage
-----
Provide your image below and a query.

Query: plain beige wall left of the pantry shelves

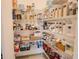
[1,0,15,59]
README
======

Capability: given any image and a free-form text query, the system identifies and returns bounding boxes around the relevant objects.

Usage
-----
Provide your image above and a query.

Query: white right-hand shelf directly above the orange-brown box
[43,30,75,46]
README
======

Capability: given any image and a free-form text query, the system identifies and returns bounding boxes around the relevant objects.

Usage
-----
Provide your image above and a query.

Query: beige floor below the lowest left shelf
[16,54,47,59]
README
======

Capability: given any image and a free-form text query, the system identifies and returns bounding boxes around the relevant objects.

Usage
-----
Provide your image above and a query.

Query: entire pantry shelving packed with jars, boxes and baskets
[12,0,78,59]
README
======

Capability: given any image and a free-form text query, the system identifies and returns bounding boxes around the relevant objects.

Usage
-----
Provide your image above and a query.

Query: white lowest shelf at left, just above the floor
[15,48,44,57]
